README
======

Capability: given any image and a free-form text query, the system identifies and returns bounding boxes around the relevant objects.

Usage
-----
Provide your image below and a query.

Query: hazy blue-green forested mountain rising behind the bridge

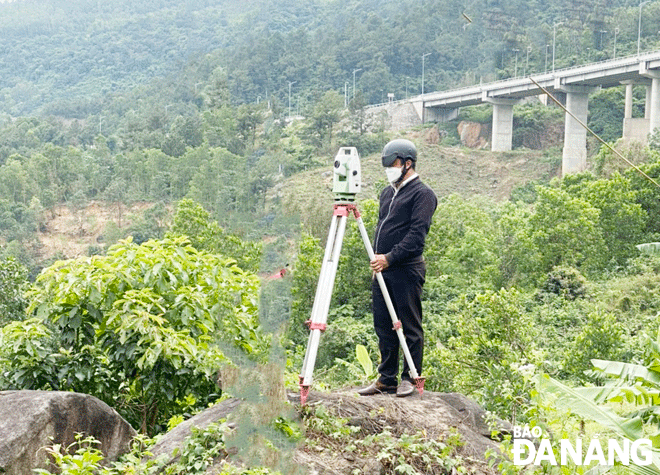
[0,0,660,118]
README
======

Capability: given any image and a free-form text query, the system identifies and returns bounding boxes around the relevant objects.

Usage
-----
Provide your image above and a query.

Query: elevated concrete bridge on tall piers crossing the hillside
[369,51,660,175]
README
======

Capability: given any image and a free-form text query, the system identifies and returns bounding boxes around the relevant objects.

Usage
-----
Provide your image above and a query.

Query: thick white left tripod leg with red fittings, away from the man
[300,208,348,405]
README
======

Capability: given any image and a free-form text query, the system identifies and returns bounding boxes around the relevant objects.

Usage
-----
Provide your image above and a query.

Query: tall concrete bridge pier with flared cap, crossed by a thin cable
[559,86,598,176]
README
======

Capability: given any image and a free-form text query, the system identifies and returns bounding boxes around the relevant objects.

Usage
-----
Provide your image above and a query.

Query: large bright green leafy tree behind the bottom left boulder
[0,238,268,434]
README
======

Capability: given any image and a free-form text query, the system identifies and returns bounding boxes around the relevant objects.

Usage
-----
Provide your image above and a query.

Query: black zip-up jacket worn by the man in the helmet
[374,177,438,266]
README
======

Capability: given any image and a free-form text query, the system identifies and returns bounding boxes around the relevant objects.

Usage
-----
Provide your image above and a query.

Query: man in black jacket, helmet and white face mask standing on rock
[358,139,438,397]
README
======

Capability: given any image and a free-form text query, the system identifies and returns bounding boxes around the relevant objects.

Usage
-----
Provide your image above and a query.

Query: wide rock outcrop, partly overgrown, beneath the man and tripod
[150,389,511,475]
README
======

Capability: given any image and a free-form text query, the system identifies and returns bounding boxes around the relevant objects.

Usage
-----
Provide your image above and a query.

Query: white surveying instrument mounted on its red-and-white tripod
[300,147,425,405]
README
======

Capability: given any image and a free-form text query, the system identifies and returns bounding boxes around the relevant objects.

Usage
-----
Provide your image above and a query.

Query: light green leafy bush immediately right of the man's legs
[426,289,540,418]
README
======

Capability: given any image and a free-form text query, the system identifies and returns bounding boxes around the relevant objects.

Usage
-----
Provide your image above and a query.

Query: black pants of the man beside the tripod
[371,262,426,386]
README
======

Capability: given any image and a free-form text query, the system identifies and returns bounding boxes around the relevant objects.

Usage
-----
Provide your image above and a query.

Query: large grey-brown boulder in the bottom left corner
[0,391,136,475]
